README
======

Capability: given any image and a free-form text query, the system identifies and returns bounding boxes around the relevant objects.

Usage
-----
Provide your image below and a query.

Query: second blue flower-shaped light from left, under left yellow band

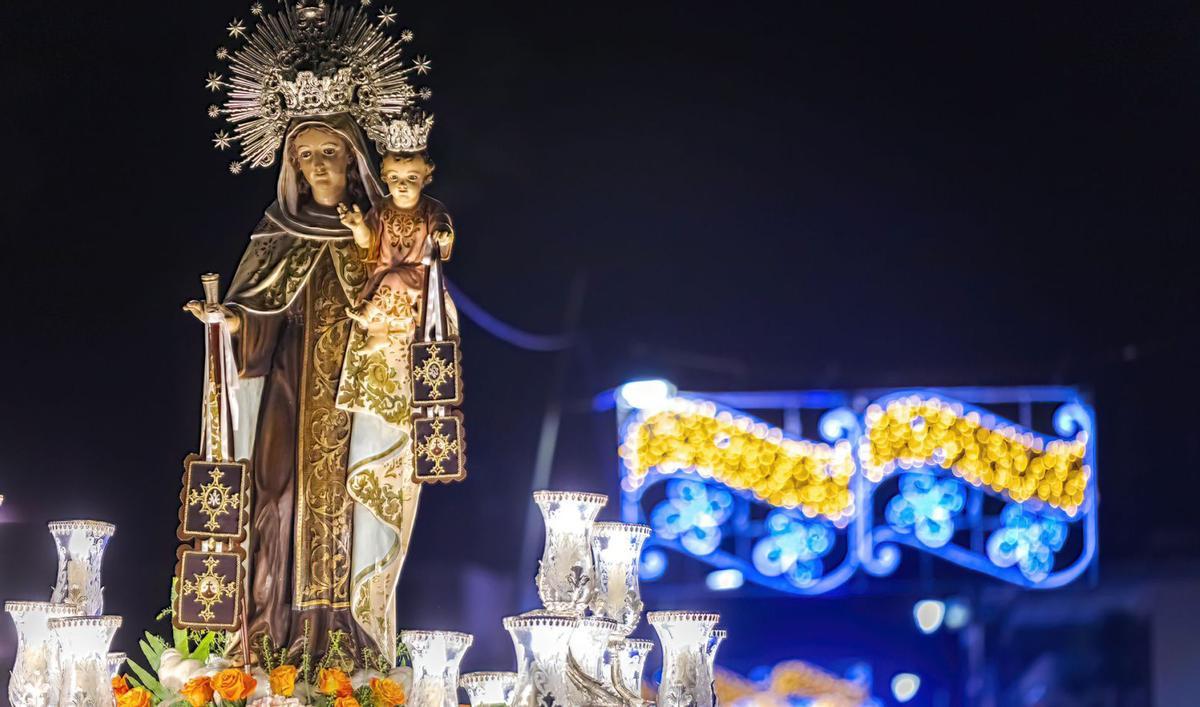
[752,509,834,588]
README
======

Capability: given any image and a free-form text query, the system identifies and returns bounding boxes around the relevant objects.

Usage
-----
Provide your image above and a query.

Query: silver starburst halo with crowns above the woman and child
[205,0,433,172]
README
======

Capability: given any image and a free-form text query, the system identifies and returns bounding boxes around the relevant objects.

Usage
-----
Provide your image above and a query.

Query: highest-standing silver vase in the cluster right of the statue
[533,491,608,616]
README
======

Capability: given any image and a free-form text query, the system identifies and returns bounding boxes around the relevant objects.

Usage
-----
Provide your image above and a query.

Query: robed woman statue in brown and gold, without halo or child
[190,114,420,660]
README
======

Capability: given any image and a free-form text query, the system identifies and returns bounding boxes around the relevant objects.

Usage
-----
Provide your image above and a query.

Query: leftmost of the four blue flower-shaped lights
[650,479,733,556]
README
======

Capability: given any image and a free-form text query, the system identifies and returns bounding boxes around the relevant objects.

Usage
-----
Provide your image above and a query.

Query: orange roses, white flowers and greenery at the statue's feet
[113,588,413,707]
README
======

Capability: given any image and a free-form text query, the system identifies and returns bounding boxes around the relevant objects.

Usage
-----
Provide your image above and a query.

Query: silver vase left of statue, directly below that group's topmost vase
[47,616,121,707]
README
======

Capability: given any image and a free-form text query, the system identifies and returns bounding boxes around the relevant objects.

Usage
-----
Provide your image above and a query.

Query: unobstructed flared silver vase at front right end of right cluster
[647,611,721,707]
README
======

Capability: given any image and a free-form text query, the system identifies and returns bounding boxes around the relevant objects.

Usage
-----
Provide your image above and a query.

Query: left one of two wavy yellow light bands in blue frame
[620,399,854,522]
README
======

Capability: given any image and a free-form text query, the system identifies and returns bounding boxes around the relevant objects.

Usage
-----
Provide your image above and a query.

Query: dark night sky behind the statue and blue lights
[0,0,1200,700]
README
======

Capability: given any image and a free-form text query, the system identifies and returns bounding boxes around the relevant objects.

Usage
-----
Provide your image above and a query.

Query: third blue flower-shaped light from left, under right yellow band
[884,472,967,547]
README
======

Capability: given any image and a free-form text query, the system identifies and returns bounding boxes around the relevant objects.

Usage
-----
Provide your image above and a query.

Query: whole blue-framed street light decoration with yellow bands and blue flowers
[614,383,1098,595]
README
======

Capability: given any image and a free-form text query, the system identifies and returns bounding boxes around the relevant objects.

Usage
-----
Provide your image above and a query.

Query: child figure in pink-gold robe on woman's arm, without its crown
[337,150,454,353]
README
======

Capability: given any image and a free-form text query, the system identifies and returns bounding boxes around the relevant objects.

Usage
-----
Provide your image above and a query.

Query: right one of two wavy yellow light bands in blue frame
[859,395,1092,516]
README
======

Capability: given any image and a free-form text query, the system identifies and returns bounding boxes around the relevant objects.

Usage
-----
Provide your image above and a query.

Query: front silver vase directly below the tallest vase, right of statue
[504,612,578,707]
